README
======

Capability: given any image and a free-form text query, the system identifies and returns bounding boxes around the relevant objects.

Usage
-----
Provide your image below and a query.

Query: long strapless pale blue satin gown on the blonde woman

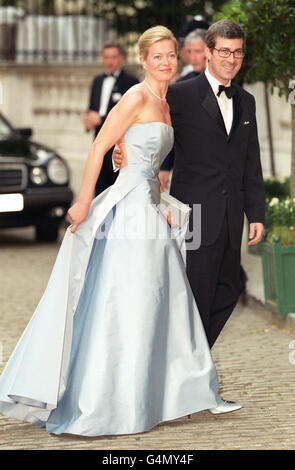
[0,122,220,436]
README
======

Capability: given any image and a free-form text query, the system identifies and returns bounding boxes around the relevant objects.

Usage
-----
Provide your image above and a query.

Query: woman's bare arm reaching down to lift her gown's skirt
[68,91,144,232]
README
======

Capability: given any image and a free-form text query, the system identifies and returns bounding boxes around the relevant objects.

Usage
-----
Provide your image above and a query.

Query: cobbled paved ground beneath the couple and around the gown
[0,229,295,450]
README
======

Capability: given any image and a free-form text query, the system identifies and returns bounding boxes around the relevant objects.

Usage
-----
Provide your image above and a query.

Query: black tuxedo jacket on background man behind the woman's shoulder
[89,70,138,136]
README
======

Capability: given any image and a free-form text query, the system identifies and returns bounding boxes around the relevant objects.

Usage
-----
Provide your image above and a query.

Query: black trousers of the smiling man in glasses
[186,211,241,348]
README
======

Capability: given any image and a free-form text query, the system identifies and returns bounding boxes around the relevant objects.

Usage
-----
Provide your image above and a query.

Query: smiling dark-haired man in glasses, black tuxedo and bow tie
[159,20,265,348]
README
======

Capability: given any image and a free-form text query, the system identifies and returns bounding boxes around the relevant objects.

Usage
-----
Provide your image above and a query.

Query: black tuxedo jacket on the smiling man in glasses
[167,73,265,249]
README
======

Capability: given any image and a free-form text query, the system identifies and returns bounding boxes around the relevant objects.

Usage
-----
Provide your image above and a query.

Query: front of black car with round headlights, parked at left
[0,114,73,241]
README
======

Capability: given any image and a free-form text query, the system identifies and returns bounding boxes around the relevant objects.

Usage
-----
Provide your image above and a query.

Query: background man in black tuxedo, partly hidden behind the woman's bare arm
[82,42,138,196]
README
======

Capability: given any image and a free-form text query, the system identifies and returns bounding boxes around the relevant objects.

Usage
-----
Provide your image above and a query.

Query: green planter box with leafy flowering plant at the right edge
[260,196,295,316]
